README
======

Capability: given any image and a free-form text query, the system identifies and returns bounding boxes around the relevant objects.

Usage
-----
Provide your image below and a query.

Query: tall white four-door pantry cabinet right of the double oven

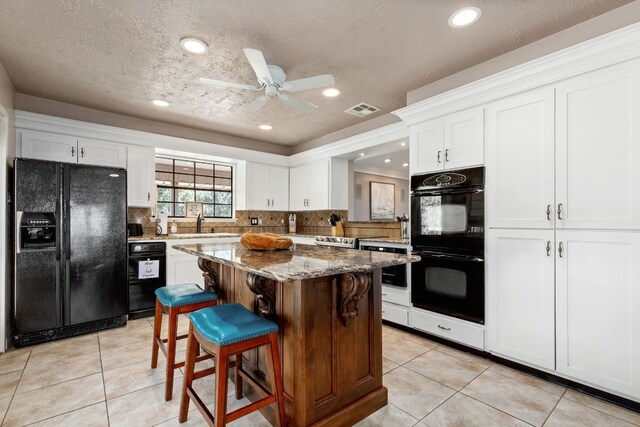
[485,61,640,400]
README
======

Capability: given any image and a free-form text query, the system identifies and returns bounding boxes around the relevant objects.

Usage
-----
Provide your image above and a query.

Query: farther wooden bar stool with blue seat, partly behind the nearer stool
[151,283,218,400]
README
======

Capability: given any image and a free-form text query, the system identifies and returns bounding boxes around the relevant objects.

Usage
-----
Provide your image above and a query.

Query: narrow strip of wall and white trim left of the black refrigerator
[0,64,16,352]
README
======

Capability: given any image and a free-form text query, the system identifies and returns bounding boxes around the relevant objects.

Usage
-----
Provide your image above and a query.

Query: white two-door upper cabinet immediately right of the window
[247,163,289,211]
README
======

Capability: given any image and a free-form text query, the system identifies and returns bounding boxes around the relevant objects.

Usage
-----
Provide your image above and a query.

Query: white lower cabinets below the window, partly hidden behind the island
[167,237,240,289]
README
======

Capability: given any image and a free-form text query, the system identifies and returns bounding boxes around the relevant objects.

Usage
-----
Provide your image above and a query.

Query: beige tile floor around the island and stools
[0,318,640,427]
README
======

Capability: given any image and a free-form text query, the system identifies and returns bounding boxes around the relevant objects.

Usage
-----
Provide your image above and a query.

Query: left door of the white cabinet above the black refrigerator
[19,130,78,163]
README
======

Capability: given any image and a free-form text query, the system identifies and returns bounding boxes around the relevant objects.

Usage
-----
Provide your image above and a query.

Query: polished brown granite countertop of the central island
[173,243,420,282]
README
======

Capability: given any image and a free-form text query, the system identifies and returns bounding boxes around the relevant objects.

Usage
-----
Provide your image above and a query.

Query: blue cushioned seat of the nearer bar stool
[188,304,278,347]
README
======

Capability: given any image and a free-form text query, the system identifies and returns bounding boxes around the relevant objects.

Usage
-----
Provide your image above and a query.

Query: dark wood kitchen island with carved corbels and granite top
[174,243,419,426]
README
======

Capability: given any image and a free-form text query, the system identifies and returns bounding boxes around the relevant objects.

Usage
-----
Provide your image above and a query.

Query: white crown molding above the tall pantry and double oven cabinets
[392,23,640,126]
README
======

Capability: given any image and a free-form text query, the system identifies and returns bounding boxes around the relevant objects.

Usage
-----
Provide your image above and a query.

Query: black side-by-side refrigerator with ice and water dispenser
[13,159,128,346]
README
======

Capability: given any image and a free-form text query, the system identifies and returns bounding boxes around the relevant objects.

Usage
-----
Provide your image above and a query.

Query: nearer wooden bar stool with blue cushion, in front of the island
[179,304,286,426]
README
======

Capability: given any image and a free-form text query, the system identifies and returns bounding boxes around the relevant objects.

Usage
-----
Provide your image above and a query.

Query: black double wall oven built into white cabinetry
[411,167,484,324]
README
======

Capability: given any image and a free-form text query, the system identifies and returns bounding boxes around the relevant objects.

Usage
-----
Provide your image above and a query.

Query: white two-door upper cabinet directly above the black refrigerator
[20,130,127,168]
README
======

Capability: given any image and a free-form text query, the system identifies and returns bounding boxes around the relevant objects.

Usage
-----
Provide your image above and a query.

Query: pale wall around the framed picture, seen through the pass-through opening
[349,172,409,221]
